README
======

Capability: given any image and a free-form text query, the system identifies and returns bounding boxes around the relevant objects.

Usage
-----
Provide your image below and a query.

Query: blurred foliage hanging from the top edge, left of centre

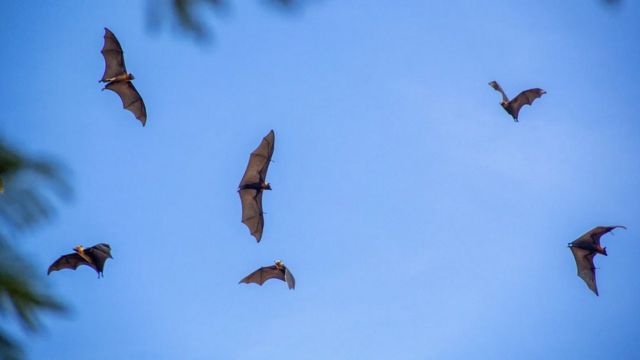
[148,0,320,40]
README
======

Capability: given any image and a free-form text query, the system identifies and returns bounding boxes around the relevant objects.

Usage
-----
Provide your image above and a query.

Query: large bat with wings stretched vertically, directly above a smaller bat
[238,130,275,242]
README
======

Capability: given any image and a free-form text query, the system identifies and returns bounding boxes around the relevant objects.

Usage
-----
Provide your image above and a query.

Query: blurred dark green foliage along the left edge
[0,141,71,360]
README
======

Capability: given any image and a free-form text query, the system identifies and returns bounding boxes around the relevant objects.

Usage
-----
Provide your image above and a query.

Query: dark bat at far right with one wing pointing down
[569,225,627,295]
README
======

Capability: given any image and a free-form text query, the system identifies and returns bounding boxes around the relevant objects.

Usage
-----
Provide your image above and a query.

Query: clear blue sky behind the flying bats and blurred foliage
[0,0,640,360]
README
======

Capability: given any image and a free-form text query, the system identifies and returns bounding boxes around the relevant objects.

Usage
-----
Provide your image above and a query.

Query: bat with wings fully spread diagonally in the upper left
[100,28,147,126]
